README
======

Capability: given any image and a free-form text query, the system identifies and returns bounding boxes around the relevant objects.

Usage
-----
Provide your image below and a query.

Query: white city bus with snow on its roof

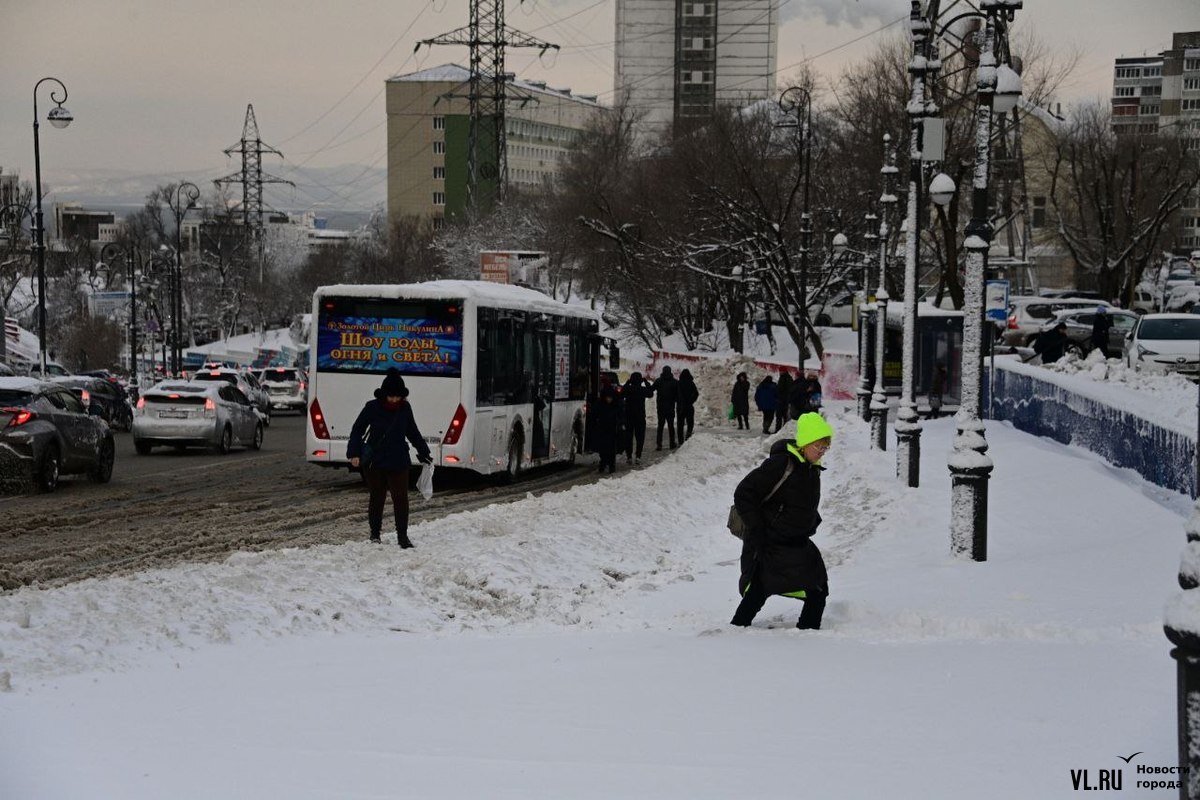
[306,281,618,476]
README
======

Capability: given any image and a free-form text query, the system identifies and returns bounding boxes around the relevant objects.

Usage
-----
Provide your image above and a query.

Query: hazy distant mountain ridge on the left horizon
[34,162,388,216]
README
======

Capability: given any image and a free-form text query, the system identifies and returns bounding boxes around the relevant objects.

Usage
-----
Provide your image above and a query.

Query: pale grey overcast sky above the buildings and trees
[0,0,1200,191]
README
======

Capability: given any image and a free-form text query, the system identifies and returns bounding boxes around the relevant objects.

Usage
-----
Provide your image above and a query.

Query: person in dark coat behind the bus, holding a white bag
[346,367,433,547]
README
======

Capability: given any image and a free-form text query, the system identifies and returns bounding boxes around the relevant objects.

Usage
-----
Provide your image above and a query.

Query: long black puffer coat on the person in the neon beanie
[733,439,829,595]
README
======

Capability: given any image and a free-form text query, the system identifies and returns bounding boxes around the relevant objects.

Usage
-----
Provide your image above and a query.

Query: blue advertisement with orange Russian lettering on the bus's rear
[316,313,462,378]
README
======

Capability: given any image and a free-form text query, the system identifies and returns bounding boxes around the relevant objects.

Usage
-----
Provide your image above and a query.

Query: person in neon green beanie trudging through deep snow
[731,413,833,630]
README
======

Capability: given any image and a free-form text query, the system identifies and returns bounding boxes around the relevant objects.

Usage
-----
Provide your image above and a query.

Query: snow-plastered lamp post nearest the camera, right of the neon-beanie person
[949,0,1021,561]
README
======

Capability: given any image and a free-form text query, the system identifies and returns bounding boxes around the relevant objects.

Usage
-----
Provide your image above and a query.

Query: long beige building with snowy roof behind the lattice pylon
[386,64,604,227]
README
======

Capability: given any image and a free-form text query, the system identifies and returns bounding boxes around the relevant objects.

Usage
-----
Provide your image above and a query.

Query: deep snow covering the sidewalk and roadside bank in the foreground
[0,410,1192,799]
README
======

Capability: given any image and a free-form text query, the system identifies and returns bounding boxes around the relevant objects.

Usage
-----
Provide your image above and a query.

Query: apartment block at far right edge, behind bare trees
[1112,31,1200,249]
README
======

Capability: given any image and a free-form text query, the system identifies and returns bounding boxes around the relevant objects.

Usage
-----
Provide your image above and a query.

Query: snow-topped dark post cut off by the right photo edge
[1163,501,1200,799]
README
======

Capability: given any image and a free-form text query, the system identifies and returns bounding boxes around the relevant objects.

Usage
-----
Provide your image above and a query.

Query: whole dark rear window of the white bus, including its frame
[314,297,462,378]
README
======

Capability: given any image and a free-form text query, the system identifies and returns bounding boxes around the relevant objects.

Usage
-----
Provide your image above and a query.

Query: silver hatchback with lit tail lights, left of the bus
[133,380,263,456]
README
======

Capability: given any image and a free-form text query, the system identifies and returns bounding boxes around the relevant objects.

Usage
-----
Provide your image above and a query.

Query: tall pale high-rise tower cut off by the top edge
[614,0,779,136]
